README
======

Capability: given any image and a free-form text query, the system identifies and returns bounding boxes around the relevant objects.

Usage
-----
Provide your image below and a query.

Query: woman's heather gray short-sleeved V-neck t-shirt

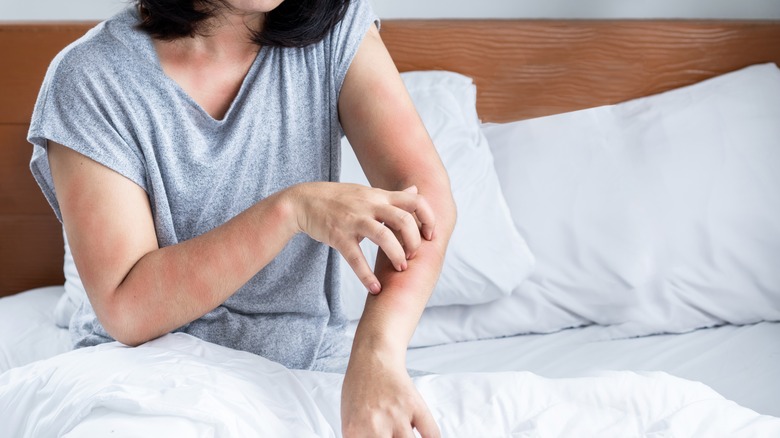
[28,0,378,369]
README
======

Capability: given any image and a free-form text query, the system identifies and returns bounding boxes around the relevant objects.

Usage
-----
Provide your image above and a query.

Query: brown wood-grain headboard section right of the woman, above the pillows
[382,20,780,122]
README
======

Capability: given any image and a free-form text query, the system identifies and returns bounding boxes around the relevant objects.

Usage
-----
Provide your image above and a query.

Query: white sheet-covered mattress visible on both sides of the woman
[0,286,780,417]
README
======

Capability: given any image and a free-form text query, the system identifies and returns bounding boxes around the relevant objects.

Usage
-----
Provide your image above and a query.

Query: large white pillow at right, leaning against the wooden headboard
[413,64,780,346]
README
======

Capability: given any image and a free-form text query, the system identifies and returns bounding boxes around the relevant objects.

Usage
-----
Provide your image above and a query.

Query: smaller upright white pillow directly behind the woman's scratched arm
[341,71,534,320]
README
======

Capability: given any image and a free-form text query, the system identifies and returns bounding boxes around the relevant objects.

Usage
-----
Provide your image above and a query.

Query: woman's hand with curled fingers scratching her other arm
[289,182,435,294]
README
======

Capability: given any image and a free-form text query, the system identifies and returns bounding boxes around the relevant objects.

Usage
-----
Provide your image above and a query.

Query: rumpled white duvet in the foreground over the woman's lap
[0,334,780,437]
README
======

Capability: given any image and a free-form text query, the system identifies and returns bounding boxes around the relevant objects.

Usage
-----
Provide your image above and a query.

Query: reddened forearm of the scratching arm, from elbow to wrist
[102,193,297,345]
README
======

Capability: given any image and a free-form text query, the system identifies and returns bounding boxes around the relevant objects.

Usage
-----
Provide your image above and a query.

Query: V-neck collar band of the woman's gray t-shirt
[109,6,268,126]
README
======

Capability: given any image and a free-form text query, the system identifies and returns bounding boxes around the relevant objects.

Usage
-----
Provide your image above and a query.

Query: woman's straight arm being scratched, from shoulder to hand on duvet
[339,26,456,438]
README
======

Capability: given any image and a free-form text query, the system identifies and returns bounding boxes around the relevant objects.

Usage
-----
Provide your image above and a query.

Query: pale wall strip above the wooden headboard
[0,0,780,21]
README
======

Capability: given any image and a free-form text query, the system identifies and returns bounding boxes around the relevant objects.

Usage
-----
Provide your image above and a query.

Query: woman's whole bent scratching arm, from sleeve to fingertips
[48,141,426,345]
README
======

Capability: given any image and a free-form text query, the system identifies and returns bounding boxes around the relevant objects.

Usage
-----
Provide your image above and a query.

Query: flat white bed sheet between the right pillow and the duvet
[407,322,780,417]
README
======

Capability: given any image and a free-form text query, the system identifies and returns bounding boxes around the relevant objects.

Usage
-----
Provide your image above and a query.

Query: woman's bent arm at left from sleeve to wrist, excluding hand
[48,141,296,345]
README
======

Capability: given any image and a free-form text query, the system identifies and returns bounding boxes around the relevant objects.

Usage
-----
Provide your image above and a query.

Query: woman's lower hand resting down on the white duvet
[341,352,440,438]
